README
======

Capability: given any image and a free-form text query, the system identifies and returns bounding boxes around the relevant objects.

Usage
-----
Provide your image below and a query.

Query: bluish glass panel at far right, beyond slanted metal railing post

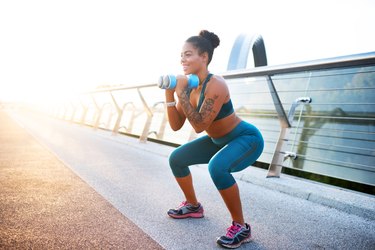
[274,66,375,185]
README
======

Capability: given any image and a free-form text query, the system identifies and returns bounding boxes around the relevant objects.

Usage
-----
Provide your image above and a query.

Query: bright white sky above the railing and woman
[0,0,375,102]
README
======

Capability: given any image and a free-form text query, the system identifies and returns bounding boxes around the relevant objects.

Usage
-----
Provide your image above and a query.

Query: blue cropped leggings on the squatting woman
[169,121,264,190]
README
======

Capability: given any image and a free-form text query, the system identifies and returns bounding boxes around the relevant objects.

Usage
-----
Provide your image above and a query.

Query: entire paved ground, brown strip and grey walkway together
[0,110,375,249]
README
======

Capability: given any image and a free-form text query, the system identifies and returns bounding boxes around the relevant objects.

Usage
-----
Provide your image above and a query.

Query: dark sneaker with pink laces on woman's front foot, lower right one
[216,221,251,248]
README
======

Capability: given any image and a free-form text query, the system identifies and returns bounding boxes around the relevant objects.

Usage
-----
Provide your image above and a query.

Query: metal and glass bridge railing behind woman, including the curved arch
[39,31,375,189]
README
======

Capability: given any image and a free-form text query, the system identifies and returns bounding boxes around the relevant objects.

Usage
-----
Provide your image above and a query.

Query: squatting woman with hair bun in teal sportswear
[165,30,263,248]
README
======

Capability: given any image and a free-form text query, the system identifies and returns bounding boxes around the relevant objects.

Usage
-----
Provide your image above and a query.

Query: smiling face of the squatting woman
[181,43,207,75]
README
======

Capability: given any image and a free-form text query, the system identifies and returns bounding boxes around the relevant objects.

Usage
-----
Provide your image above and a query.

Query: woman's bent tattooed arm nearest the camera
[176,76,229,133]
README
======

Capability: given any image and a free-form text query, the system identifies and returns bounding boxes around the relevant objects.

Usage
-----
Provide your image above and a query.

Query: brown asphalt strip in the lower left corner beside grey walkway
[0,110,162,249]
